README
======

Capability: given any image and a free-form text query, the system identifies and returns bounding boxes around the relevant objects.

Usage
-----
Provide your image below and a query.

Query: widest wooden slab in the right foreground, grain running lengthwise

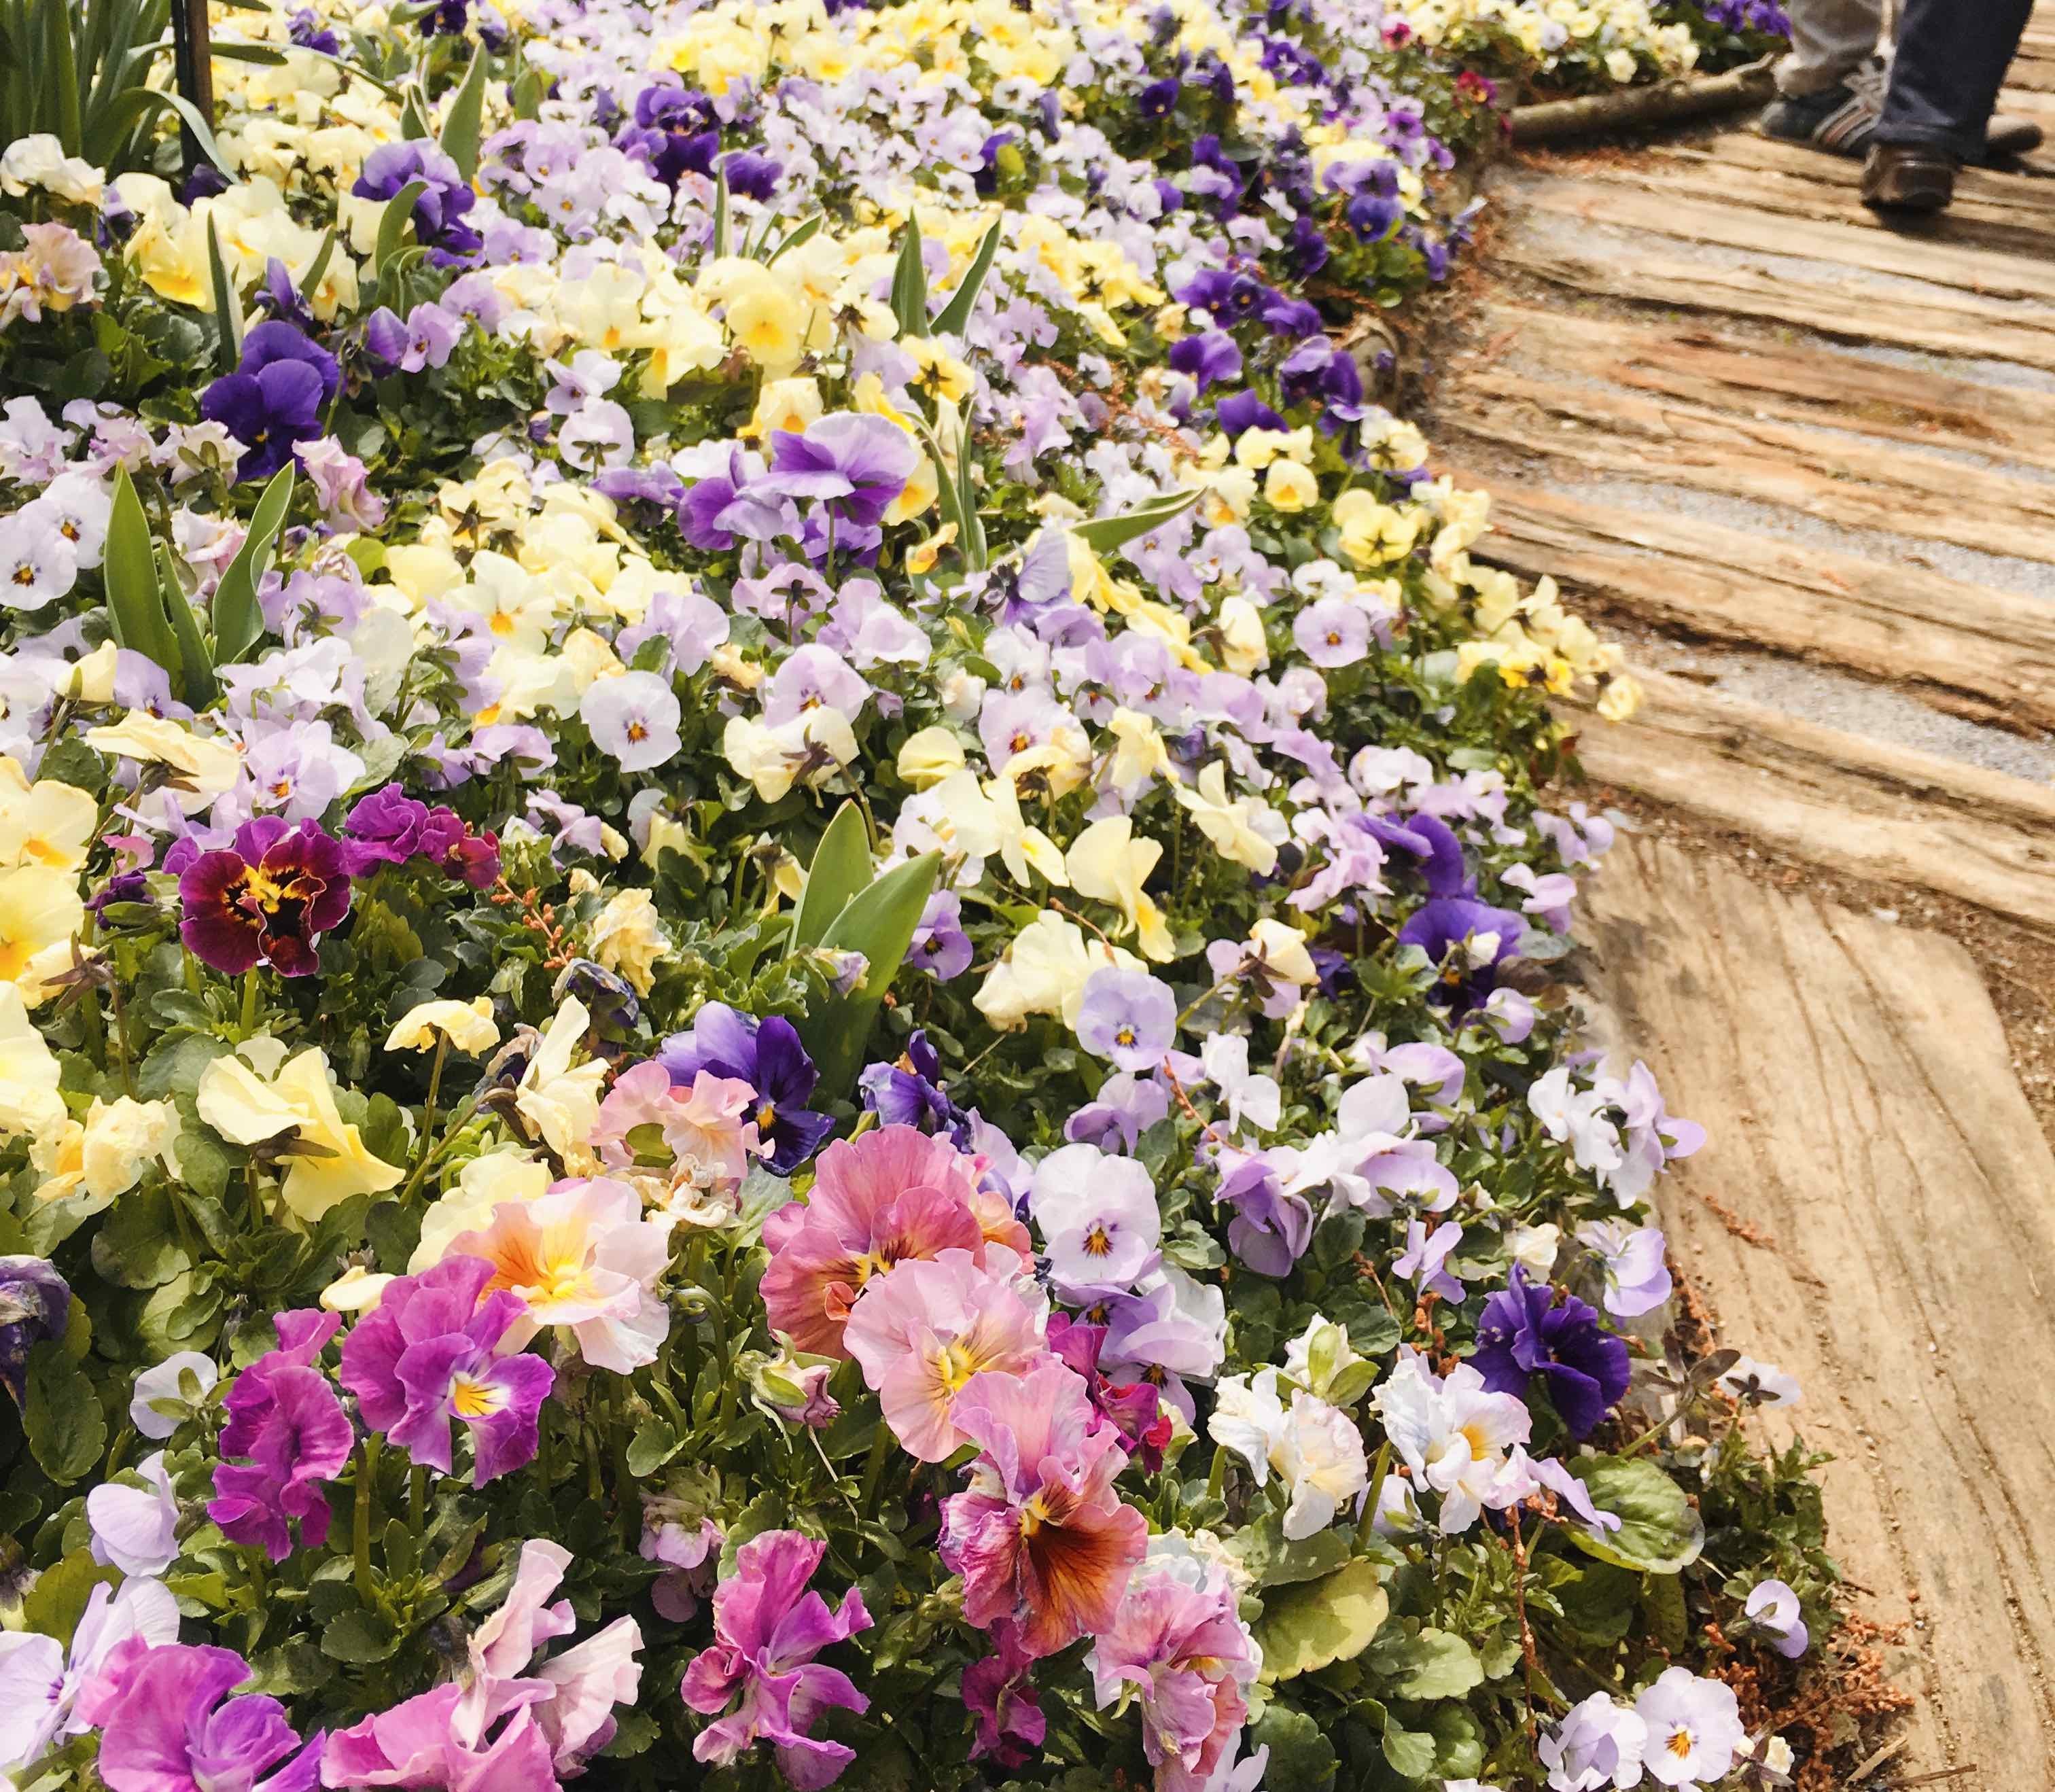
[1585,839,2055,1792]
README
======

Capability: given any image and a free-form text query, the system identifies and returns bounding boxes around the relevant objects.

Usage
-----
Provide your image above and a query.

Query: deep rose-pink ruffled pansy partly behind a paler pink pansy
[762,1126,984,1356]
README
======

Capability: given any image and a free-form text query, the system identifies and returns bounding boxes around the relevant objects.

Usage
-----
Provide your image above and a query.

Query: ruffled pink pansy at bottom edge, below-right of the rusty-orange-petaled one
[1085,1553,1262,1792]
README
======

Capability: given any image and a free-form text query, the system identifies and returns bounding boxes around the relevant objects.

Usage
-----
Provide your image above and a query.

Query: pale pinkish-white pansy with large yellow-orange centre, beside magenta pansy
[450,1178,670,1375]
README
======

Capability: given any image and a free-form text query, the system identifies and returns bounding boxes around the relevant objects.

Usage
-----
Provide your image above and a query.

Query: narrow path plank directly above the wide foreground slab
[1578,672,2055,932]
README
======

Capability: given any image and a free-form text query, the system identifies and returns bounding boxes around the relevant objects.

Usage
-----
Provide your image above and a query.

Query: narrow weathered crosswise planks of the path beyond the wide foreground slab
[1433,35,2055,931]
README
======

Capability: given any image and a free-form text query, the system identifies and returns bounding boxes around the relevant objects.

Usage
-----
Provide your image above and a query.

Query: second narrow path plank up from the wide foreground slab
[1457,471,2055,728]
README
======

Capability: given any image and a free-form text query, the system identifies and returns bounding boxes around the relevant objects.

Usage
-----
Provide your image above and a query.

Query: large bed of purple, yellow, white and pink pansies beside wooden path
[0,0,1833,1792]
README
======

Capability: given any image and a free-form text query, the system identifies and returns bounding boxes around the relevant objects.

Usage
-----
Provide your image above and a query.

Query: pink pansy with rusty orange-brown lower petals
[941,1363,1148,1656]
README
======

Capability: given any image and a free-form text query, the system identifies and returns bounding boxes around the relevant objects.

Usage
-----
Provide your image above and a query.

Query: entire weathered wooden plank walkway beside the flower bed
[1435,24,2055,1788]
